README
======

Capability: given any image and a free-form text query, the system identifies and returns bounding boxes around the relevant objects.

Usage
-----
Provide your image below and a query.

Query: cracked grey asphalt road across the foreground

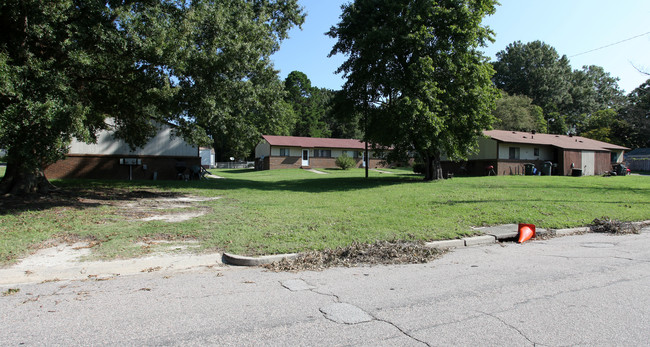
[0,228,650,346]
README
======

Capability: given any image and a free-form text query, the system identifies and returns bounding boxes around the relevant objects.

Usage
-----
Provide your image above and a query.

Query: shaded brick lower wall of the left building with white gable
[45,155,201,180]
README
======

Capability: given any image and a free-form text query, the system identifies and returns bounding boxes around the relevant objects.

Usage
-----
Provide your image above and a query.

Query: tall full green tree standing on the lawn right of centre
[328,0,498,180]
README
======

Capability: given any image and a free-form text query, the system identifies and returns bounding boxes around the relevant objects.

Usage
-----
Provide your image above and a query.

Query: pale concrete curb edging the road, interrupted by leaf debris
[222,221,612,266]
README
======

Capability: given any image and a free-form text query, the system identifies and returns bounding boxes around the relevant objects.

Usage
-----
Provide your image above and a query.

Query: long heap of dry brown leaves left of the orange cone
[264,241,444,271]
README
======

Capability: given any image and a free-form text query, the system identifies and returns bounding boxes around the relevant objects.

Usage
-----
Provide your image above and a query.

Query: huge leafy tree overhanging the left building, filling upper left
[0,0,304,193]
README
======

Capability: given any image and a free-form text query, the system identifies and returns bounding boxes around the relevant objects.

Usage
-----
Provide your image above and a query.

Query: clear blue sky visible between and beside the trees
[272,0,650,92]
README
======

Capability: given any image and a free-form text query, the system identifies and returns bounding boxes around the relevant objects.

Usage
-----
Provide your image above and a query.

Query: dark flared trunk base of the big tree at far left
[0,161,56,195]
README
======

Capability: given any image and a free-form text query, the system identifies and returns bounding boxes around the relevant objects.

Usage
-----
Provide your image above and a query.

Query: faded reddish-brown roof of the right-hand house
[483,130,629,151]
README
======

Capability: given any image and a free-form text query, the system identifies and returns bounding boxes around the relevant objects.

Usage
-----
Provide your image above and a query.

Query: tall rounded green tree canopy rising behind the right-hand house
[493,41,625,133]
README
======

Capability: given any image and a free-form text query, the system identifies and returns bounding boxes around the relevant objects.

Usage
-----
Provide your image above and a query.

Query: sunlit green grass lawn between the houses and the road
[0,169,650,262]
